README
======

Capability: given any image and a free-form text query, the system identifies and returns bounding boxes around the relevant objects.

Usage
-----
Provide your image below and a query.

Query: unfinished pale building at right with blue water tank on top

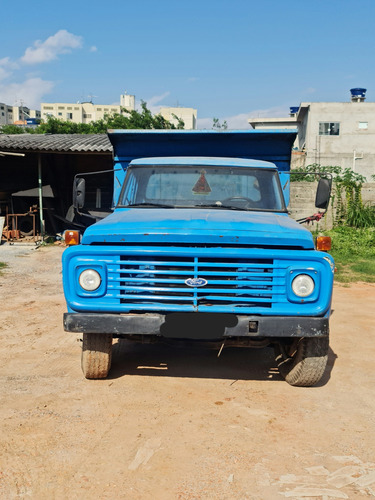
[248,88,375,180]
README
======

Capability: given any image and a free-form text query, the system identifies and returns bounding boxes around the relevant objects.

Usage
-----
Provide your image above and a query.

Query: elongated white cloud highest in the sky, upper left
[21,30,82,64]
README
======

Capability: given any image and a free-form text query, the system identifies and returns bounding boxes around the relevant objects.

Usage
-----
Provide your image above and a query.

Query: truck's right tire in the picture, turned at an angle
[275,337,329,387]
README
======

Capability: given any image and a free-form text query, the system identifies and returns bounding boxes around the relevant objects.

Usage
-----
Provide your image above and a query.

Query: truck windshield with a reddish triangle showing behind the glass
[119,165,285,212]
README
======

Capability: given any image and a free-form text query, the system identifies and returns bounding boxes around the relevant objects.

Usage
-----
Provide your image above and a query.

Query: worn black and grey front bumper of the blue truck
[64,313,329,339]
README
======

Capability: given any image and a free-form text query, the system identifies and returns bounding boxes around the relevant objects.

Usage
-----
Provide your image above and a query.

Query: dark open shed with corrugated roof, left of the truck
[0,134,113,241]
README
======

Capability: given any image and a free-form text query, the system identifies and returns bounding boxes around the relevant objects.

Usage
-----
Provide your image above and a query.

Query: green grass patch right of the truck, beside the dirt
[325,227,375,283]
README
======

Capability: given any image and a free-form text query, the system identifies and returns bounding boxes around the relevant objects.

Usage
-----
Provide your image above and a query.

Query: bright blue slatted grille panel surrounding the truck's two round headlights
[63,245,333,316]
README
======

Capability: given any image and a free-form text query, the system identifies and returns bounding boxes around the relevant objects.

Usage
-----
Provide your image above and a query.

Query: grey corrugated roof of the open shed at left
[0,134,113,153]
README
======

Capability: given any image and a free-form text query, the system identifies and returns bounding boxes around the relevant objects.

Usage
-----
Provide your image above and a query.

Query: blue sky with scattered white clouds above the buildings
[0,0,375,129]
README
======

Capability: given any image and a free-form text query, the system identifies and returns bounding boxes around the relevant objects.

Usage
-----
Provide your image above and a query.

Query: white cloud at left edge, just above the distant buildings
[0,78,55,109]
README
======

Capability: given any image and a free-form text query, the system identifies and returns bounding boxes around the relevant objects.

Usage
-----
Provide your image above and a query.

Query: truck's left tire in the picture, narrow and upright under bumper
[81,333,112,379]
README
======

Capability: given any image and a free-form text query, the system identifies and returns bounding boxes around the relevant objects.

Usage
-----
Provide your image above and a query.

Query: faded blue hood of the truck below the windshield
[82,208,314,249]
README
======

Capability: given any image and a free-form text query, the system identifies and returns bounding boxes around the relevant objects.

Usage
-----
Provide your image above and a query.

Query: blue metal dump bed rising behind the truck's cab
[108,130,297,204]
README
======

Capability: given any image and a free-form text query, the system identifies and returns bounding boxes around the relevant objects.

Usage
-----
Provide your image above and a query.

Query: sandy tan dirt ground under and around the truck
[0,245,375,500]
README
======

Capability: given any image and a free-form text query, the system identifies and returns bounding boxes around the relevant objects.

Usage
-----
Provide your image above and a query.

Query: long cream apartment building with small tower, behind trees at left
[41,93,135,123]
